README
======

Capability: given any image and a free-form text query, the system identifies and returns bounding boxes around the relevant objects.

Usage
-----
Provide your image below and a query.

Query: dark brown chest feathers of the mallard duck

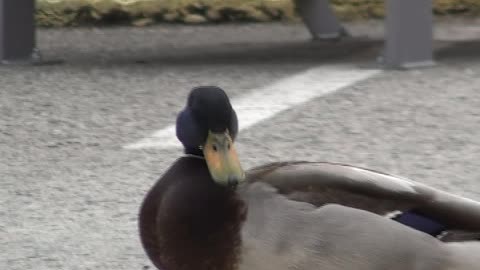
[140,159,246,270]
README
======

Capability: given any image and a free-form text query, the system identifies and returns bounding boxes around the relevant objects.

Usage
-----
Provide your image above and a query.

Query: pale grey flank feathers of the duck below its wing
[239,183,448,270]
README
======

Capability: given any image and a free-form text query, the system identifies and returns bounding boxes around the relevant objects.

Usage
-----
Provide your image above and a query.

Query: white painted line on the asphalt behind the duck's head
[125,65,381,149]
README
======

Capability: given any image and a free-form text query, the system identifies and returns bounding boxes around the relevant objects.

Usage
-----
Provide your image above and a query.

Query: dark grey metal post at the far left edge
[0,0,35,63]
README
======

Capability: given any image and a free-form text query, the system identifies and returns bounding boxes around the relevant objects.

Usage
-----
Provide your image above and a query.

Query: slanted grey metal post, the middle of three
[295,0,346,39]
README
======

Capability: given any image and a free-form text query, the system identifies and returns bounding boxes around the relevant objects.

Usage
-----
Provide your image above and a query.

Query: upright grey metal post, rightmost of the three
[383,0,434,68]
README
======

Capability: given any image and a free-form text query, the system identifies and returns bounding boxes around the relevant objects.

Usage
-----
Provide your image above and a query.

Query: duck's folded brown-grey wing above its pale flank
[247,162,480,241]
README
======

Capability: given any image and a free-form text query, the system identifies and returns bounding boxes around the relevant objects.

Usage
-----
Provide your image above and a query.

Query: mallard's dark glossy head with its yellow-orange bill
[176,86,245,187]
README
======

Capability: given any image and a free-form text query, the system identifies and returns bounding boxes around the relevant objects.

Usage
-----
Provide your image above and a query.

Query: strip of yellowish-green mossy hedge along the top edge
[36,0,480,26]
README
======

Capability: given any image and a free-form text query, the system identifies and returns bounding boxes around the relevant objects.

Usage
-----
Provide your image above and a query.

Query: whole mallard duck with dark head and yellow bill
[139,86,480,270]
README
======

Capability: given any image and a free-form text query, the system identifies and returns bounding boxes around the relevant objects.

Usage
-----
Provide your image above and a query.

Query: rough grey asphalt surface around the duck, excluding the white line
[0,21,480,270]
